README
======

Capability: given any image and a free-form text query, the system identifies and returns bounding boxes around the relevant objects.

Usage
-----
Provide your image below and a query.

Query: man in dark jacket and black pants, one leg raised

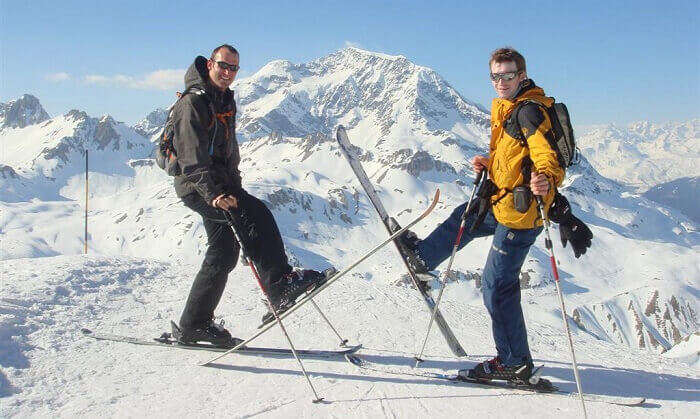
[170,45,326,344]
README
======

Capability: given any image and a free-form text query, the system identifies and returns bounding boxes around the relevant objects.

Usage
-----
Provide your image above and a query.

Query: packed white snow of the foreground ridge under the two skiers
[0,256,700,418]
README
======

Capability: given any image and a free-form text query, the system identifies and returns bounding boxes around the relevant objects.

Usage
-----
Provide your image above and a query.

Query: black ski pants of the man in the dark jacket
[180,191,292,328]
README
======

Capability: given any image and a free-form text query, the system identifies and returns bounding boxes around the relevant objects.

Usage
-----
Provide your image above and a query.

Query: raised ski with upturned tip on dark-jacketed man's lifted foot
[200,189,440,365]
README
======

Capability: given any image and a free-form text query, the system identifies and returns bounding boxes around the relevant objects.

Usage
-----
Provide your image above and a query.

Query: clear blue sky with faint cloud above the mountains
[0,0,700,125]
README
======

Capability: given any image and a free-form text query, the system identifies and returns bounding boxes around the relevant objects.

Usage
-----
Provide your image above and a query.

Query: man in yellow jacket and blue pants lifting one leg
[402,48,564,382]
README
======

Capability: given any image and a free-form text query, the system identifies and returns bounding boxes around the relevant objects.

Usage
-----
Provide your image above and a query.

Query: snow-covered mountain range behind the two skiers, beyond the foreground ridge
[0,48,700,370]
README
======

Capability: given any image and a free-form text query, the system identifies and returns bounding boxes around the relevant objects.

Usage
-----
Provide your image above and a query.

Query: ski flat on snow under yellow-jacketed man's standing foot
[345,354,646,406]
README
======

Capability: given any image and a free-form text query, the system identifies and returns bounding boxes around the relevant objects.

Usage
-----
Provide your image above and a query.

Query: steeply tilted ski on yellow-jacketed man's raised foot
[336,125,467,357]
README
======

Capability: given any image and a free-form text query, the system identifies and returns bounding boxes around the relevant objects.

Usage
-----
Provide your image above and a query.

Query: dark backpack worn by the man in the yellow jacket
[508,100,579,169]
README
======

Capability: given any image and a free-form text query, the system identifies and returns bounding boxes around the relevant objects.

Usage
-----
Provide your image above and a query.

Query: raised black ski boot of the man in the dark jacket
[260,268,338,327]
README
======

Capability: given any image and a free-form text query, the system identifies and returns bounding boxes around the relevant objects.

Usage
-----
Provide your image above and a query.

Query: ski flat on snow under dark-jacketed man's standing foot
[81,329,362,358]
